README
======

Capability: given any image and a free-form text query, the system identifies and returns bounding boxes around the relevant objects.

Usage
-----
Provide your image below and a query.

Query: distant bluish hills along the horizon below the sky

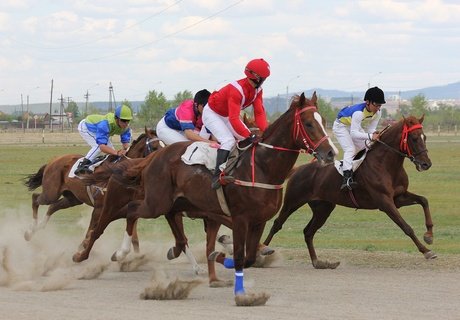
[0,82,460,114]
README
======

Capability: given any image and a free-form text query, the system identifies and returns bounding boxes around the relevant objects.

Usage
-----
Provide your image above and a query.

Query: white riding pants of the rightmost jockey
[332,120,366,171]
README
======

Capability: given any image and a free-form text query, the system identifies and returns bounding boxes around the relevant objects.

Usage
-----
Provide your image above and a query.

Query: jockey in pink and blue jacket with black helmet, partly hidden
[156,89,211,145]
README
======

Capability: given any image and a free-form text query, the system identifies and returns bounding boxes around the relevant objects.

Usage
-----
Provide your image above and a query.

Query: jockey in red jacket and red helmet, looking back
[203,59,270,189]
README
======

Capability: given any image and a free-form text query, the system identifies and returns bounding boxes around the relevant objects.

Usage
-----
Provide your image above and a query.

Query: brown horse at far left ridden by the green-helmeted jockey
[24,128,164,250]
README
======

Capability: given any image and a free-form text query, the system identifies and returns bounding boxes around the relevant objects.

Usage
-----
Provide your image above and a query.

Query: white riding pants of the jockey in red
[202,105,244,151]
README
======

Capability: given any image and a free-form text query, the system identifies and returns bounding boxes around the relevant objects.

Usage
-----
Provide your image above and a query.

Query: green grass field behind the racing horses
[0,131,460,254]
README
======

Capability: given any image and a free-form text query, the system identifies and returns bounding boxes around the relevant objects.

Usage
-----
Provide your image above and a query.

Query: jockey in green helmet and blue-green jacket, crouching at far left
[75,105,133,174]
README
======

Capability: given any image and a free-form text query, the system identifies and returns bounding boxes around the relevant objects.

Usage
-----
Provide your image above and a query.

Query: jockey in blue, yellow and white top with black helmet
[332,87,386,190]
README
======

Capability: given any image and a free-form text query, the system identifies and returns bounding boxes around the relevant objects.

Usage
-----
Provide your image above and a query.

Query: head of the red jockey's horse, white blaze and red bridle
[289,91,338,163]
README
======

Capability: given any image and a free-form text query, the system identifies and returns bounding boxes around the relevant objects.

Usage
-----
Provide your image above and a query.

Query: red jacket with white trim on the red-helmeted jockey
[208,78,268,138]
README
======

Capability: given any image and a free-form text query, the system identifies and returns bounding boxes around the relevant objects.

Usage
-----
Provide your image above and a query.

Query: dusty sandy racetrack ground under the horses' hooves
[0,210,460,320]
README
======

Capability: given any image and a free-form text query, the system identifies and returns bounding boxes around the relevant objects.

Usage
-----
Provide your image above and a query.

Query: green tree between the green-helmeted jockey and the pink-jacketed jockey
[139,90,171,126]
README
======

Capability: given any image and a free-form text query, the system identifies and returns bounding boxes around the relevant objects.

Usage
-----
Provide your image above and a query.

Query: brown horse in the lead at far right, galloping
[264,116,436,269]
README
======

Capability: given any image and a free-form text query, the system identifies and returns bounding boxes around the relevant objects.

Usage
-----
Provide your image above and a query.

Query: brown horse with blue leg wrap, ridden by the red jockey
[73,92,335,305]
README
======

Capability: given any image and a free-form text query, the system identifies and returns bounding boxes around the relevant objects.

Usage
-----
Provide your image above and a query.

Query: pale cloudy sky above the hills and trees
[0,0,460,105]
